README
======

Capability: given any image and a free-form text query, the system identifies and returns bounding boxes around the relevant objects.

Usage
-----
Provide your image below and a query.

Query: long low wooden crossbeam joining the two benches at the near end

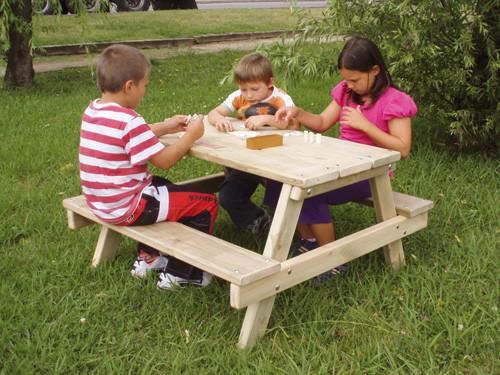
[230,212,427,309]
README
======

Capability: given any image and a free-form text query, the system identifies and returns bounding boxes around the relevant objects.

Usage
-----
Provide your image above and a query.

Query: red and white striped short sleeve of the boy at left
[124,117,165,166]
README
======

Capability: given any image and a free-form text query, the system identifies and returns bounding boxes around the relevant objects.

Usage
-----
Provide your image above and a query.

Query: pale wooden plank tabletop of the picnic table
[160,117,400,188]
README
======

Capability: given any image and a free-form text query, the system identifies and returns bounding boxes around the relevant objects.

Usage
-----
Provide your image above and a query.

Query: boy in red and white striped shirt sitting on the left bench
[79,44,218,289]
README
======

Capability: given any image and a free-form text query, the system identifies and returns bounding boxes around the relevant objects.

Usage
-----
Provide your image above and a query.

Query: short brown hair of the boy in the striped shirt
[97,44,151,92]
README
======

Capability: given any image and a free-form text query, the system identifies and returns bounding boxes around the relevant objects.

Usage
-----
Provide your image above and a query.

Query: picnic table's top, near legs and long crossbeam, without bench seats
[161,118,432,347]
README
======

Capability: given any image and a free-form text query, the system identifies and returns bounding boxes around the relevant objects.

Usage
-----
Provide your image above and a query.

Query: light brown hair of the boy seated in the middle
[234,53,274,83]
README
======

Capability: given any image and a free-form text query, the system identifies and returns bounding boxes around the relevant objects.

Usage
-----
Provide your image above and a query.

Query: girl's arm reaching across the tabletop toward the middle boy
[275,100,341,133]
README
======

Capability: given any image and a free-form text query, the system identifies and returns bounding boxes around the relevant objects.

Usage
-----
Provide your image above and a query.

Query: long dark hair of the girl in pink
[337,36,395,104]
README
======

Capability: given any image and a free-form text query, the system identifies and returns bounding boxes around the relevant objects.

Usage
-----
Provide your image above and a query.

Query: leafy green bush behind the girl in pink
[267,0,500,149]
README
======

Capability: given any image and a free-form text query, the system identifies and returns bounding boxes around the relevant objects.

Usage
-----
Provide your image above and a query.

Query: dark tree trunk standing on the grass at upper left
[4,0,35,88]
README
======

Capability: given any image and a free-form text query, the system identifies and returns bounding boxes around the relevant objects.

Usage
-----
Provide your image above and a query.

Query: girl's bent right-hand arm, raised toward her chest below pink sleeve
[340,108,411,159]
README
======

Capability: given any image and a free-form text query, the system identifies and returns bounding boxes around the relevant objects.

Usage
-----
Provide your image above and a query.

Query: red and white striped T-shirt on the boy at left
[79,100,164,223]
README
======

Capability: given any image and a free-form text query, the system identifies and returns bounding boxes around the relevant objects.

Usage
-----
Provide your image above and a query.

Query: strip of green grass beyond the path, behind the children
[33,9,321,46]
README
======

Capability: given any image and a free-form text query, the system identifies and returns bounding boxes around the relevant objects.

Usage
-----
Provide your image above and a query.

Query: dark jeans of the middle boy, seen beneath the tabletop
[219,168,264,228]
